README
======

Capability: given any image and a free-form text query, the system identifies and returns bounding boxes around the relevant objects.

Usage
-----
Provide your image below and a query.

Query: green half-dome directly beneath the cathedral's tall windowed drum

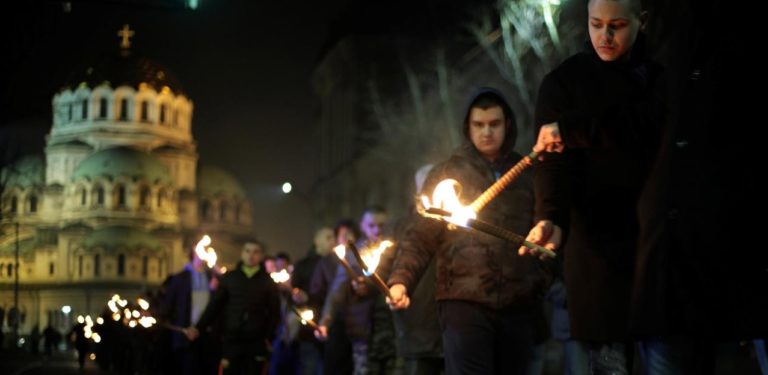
[72,147,173,184]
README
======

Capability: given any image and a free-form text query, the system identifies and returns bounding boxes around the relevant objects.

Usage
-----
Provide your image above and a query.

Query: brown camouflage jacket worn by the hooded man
[388,144,551,309]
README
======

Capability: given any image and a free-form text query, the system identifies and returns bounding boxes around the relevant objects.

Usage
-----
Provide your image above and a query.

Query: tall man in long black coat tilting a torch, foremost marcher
[521,0,665,373]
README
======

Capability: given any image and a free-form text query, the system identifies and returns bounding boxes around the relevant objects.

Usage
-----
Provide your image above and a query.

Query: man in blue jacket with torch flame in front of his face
[160,248,219,375]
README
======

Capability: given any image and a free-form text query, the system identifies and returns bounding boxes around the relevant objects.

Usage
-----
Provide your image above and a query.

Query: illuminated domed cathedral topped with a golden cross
[0,26,254,334]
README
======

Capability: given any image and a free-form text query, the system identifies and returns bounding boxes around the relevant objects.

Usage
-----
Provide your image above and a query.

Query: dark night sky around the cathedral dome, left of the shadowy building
[0,0,338,255]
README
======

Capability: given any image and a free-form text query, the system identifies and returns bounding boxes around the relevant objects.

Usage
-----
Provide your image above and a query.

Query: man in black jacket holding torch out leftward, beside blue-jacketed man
[187,241,280,374]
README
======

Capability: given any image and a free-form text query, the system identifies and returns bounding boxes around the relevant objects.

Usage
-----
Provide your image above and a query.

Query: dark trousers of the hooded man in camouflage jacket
[438,301,536,375]
